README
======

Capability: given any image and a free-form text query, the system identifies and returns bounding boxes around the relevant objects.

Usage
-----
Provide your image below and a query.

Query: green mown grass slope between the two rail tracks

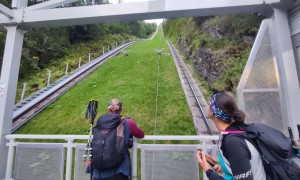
[16,29,196,135]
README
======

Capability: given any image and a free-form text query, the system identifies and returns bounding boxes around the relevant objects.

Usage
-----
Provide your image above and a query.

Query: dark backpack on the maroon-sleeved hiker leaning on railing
[92,114,125,170]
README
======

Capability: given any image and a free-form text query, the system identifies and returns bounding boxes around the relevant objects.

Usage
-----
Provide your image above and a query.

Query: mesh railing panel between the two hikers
[141,145,199,180]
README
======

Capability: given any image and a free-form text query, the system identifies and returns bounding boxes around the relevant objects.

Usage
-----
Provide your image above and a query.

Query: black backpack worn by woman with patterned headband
[232,124,300,180]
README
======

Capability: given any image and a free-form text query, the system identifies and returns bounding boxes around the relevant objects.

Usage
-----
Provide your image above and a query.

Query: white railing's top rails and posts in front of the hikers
[5,134,219,180]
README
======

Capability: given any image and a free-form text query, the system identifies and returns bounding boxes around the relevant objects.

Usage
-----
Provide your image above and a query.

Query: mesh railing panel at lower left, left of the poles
[14,143,64,180]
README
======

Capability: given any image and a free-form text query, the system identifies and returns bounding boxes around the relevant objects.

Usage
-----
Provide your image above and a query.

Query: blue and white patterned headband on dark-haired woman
[209,93,231,122]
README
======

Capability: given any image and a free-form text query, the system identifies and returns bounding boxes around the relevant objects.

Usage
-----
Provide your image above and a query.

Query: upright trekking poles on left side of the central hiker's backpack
[83,99,98,179]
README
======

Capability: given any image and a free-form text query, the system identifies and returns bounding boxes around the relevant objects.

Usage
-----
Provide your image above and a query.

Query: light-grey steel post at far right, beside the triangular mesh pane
[272,9,300,137]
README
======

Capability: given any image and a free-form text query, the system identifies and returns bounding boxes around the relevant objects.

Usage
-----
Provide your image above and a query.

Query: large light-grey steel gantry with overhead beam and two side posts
[0,0,300,179]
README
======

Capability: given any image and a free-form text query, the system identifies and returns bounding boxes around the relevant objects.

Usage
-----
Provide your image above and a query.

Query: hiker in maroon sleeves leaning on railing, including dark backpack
[92,99,144,180]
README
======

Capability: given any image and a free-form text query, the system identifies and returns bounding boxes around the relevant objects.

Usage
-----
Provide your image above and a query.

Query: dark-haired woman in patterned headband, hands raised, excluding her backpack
[197,93,266,180]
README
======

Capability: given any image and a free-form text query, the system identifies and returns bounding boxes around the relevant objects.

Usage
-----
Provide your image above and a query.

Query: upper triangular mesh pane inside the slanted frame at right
[245,28,278,89]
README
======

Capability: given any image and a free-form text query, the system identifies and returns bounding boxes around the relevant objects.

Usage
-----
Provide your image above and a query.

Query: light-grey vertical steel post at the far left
[0,26,24,179]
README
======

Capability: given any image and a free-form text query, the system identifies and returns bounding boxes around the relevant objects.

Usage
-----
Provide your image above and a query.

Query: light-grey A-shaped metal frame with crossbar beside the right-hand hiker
[237,8,300,137]
